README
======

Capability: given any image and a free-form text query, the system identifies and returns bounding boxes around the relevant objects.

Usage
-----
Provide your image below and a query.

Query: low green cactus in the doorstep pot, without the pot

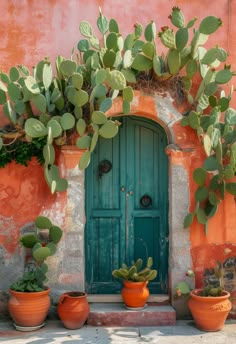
[112,257,157,282]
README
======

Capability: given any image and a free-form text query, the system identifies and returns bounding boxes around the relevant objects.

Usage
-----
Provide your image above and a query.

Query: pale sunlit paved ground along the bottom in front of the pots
[0,320,236,344]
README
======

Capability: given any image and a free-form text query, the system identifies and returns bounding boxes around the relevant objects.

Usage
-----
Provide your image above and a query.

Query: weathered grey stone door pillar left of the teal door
[53,160,85,291]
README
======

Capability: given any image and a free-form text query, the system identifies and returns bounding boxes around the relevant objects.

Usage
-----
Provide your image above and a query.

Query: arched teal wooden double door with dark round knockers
[85,116,168,294]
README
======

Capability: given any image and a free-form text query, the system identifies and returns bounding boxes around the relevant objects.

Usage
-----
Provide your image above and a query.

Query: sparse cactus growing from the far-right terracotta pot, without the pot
[175,262,224,297]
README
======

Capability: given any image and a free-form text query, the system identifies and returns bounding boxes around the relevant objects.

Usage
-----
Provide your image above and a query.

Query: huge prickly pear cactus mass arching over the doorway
[0,7,236,232]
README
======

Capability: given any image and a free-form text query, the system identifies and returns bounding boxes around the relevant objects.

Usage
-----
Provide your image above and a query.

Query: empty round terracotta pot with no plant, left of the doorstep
[57,292,90,330]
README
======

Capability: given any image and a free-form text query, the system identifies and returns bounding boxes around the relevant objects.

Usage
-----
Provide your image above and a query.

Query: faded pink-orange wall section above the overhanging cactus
[0,0,236,77]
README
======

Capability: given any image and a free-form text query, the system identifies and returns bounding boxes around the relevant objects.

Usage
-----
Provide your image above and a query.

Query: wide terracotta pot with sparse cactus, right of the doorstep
[176,262,232,331]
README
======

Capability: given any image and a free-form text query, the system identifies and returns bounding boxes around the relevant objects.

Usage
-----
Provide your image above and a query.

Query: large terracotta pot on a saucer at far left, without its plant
[8,288,50,327]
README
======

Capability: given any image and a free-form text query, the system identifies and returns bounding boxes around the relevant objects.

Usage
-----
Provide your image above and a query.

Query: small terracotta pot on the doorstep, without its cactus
[121,280,149,308]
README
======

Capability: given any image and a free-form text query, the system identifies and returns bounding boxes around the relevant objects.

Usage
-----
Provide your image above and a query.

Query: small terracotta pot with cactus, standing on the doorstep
[112,257,157,309]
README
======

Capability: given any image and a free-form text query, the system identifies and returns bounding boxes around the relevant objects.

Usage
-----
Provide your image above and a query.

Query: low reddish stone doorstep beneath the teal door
[87,302,176,327]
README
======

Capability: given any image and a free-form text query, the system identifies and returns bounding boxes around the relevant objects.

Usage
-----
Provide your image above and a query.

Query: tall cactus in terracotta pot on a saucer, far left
[8,216,62,331]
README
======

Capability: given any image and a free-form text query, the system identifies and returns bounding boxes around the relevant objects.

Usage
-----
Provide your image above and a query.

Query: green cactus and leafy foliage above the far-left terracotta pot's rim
[10,216,63,292]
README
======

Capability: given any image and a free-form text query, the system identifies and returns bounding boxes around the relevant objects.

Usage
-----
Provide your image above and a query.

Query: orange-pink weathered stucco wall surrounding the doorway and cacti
[0,0,236,294]
